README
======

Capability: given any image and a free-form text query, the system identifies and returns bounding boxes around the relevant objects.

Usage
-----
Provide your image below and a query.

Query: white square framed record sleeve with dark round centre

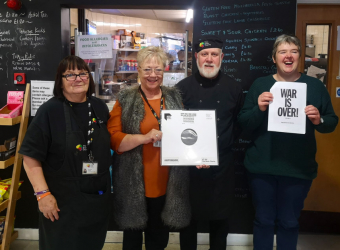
[161,110,218,166]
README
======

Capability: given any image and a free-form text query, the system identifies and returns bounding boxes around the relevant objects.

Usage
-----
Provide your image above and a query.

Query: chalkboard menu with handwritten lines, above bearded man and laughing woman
[193,0,296,90]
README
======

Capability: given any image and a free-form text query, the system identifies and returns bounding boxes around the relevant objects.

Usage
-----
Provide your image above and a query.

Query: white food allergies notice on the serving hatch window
[77,34,112,59]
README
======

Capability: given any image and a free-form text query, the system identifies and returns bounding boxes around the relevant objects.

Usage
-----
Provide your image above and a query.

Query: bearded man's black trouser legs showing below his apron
[179,219,229,250]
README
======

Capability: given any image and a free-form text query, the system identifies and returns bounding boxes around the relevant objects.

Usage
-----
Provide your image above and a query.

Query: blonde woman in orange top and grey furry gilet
[108,46,190,250]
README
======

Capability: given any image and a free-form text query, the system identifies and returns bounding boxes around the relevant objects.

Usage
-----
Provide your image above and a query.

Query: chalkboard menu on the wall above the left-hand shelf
[0,0,61,106]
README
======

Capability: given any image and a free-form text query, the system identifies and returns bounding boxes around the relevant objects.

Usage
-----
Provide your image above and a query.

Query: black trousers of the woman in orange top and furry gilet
[123,195,169,250]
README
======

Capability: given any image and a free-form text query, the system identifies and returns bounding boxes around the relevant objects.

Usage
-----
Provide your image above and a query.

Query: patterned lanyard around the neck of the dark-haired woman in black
[65,98,99,161]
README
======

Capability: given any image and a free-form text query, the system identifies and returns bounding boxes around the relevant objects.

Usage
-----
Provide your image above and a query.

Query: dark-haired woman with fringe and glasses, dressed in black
[19,56,111,250]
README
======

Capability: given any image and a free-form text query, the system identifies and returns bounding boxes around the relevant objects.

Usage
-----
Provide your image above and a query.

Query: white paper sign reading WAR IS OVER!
[268,82,307,134]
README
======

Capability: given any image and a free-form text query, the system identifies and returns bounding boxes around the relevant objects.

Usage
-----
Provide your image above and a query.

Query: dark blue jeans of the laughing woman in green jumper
[249,173,312,250]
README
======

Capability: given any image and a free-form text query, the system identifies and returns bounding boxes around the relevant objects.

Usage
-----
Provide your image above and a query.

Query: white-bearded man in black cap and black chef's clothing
[176,37,243,250]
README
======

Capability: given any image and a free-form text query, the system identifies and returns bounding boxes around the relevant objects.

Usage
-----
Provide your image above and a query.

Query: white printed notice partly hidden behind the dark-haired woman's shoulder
[31,81,54,116]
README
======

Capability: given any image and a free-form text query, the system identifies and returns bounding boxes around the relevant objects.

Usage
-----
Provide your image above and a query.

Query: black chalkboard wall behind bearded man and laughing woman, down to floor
[193,0,296,233]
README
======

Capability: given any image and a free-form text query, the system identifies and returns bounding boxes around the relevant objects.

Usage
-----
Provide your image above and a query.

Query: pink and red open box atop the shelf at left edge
[0,91,24,118]
